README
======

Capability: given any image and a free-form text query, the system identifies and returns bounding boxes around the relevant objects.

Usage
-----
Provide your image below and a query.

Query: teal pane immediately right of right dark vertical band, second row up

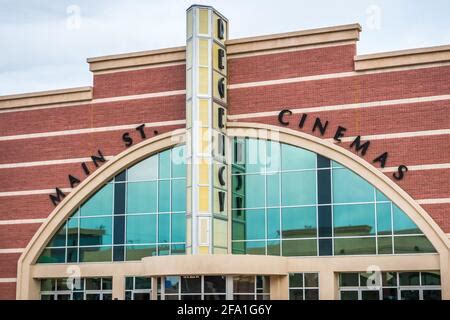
[333,204,375,236]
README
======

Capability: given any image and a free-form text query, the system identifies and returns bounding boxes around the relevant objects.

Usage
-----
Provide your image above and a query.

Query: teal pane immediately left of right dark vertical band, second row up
[281,206,317,239]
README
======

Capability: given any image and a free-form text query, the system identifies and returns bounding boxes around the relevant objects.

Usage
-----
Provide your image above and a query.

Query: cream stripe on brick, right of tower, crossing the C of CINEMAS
[228,94,450,120]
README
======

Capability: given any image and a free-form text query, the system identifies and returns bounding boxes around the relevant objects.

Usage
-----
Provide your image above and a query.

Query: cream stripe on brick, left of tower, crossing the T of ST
[0,120,186,141]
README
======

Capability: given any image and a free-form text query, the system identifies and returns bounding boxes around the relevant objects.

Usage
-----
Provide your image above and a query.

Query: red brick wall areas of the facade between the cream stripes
[0,45,450,299]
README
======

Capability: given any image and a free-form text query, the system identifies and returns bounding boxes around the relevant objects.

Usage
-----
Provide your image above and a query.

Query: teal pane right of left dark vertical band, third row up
[127,181,157,213]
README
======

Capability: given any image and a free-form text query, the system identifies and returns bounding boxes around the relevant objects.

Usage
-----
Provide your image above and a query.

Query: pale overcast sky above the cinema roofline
[0,0,450,95]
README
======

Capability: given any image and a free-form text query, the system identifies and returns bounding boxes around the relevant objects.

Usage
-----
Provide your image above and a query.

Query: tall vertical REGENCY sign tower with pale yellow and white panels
[186,5,229,254]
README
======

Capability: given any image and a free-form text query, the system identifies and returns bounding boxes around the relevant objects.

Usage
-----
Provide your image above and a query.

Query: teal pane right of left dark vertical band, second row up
[126,214,157,244]
